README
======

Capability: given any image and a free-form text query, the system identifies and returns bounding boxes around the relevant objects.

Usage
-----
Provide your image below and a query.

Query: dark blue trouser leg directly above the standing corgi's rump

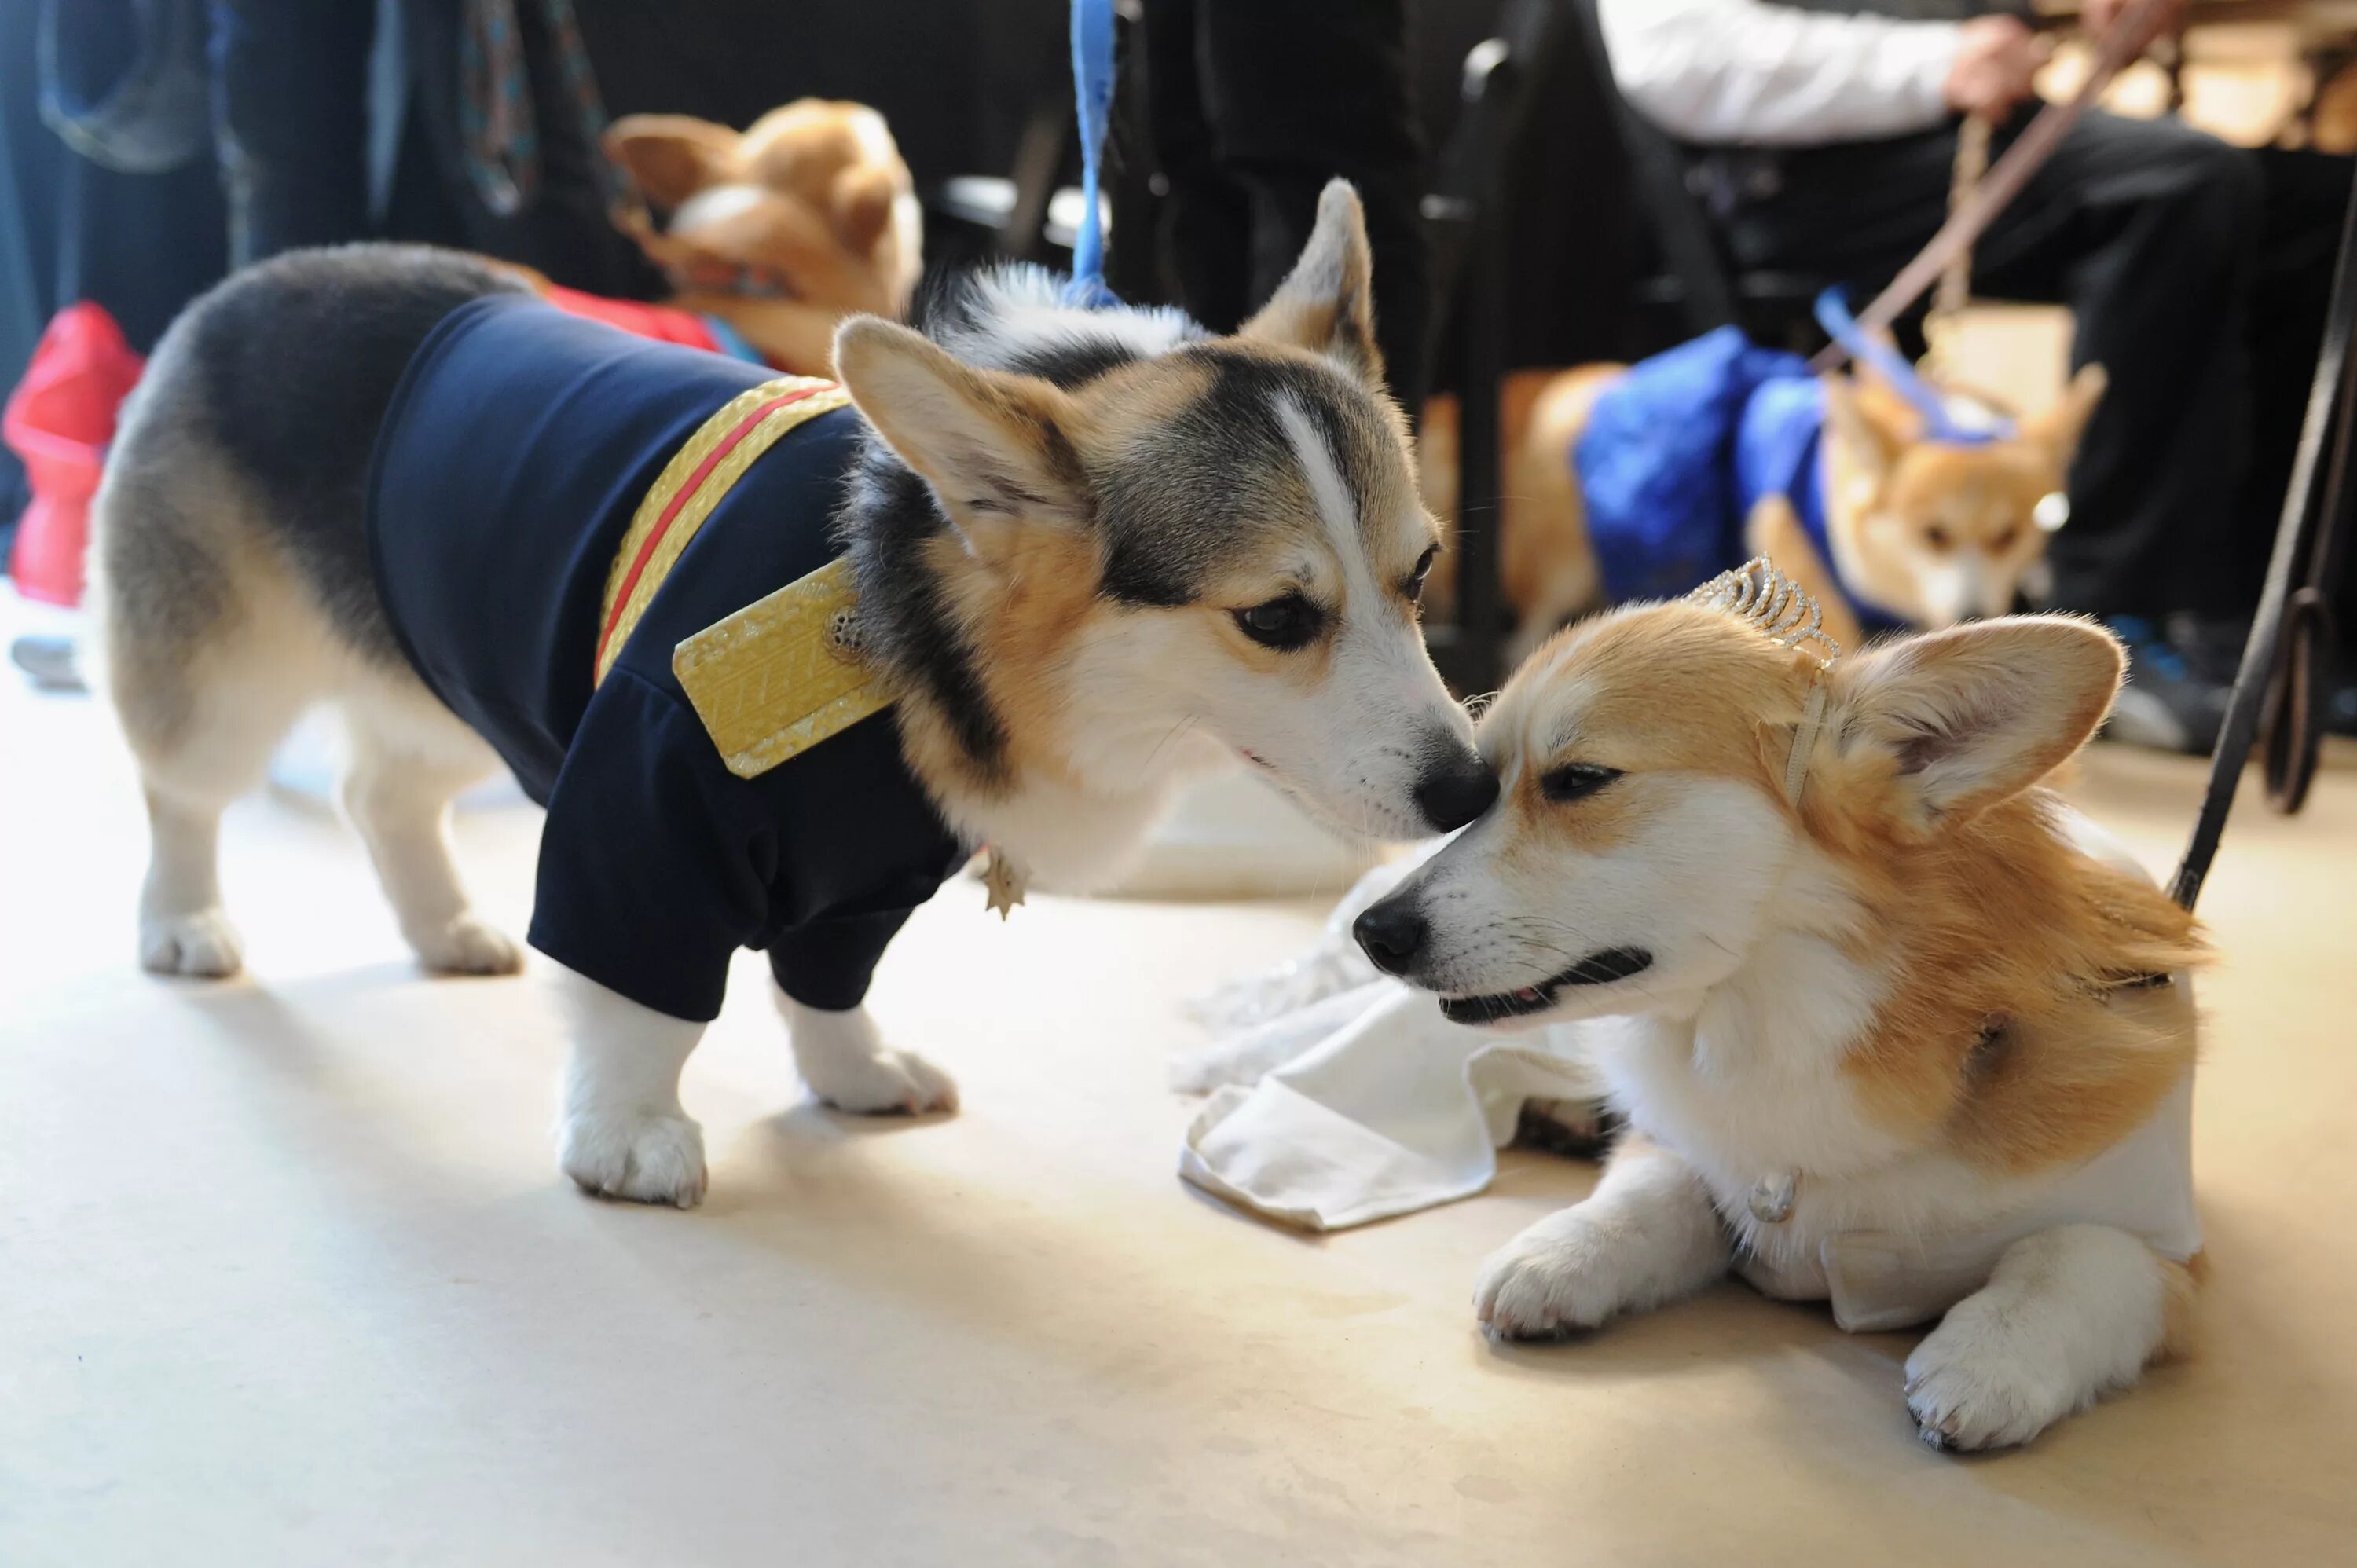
[212,0,377,266]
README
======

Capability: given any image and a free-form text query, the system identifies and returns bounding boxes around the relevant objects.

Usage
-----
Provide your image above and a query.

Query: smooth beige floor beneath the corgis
[0,601,2357,1568]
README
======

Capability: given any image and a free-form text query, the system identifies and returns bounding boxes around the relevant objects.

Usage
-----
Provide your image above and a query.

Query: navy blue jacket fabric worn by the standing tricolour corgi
[368,295,969,1021]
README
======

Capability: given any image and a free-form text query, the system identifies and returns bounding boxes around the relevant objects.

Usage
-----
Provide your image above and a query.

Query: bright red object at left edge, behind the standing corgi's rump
[0,299,146,603]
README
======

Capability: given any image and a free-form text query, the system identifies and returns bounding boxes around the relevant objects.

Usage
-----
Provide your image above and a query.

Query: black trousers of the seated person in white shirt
[1728,113,2350,615]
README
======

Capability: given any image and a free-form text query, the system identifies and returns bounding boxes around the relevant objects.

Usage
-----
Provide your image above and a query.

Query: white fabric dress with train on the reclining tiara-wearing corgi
[1174,811,2201,1330]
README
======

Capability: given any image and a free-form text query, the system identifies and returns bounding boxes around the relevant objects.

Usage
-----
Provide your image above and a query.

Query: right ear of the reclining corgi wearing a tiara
[1829,615,2126,833]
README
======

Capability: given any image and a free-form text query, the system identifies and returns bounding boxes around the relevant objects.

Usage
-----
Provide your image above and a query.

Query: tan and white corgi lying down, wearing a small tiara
[1355,563,2201,1448]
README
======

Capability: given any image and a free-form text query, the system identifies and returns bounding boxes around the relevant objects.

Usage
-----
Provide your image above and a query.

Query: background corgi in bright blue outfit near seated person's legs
[1421,342,2107,660]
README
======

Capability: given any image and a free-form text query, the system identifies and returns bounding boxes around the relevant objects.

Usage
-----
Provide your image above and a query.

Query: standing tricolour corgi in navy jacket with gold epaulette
[92,181,1497,1207]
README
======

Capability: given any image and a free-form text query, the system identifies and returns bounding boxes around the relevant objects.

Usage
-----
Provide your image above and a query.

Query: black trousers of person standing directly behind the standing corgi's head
[1143,0,1433,410]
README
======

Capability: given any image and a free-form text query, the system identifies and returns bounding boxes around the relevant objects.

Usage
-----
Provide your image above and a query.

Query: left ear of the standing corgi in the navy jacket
[834,316,1091,559]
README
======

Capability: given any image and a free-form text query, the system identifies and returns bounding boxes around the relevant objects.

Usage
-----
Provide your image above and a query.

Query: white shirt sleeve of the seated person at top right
[1598,0,1961,146]
